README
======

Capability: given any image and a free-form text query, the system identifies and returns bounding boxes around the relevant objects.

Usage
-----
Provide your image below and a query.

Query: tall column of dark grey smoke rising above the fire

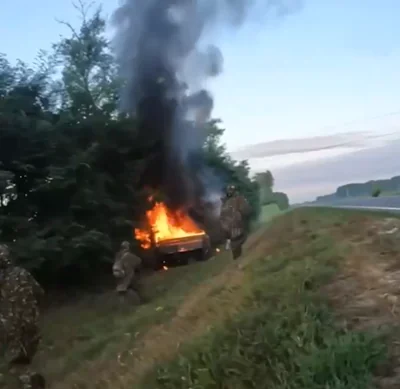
[113,0,300,215]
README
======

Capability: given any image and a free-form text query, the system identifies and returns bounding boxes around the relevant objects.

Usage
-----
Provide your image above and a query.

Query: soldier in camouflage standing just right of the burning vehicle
[220,185,250,259]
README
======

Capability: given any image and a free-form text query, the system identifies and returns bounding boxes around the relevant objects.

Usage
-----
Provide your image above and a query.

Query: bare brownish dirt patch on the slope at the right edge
[325,218,400,389]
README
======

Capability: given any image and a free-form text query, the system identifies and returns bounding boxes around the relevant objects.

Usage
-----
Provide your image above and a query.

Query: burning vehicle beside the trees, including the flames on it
[134,199,212,268]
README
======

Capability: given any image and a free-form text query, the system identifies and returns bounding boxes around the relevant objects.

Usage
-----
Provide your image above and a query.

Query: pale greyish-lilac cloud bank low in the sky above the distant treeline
[234,132,400,202]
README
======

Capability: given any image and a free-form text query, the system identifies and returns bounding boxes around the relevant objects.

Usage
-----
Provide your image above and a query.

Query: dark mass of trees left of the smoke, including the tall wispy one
[0,5,147,282]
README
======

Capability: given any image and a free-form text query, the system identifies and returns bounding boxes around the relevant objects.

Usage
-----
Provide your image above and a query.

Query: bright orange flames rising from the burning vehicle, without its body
[135,199,205,249]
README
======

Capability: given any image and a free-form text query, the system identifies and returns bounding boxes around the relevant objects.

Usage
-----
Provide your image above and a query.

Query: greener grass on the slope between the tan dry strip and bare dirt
[142,230,386,389]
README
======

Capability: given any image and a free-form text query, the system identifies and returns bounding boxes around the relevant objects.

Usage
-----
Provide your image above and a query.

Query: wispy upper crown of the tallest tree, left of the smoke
[54,1,120,117]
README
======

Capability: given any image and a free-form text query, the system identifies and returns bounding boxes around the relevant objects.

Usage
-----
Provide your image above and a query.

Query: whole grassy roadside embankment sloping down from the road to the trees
[32,208,400,389]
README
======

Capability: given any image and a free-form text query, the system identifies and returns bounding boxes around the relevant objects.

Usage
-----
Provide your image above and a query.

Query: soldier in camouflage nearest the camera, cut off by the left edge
[0,245,45,389]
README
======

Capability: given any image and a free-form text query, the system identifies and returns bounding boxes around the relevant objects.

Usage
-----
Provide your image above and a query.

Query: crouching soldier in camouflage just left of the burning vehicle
[113,241,144,303]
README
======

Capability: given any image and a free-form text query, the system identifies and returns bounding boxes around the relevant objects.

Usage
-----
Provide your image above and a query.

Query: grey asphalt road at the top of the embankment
[303,196,400,213]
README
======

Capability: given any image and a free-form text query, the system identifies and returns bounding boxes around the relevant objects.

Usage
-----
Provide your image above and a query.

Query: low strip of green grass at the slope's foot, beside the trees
[34,253,231,381]
